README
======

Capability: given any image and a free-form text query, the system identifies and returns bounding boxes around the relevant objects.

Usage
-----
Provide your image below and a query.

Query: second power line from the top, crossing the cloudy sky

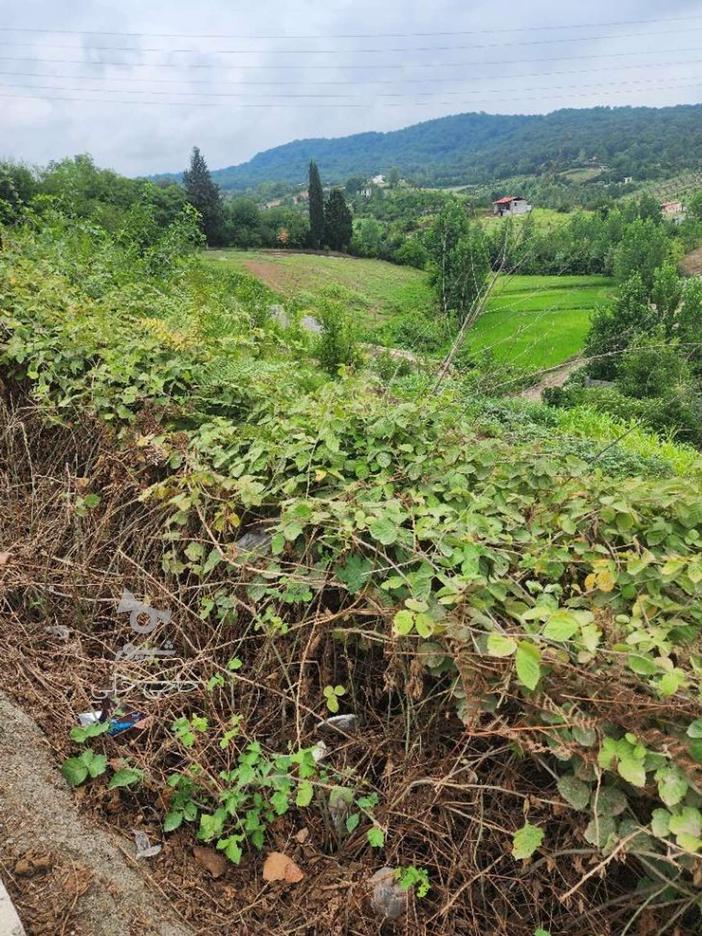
[0,26,702,55]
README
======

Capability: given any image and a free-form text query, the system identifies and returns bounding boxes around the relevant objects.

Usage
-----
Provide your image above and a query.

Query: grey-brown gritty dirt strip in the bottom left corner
[0,694,192,936]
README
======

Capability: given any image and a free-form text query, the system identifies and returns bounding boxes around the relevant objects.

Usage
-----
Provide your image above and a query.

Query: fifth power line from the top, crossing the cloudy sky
[0,76,702,100]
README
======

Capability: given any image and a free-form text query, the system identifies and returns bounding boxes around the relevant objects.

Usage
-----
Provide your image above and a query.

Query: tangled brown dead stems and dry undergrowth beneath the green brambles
[0,394,694,936]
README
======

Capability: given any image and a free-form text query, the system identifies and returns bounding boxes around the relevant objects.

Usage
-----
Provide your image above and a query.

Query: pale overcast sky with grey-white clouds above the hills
[0,0,702,176]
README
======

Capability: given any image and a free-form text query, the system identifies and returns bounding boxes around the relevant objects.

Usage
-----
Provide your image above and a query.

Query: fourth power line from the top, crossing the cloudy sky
[0,59,702,90]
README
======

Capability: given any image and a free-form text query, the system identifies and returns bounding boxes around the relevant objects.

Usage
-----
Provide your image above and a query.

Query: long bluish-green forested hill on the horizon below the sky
[162,105,702,189]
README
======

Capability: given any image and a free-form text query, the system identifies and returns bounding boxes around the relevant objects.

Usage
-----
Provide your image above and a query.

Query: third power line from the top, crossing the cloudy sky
[0,46,700,71]
